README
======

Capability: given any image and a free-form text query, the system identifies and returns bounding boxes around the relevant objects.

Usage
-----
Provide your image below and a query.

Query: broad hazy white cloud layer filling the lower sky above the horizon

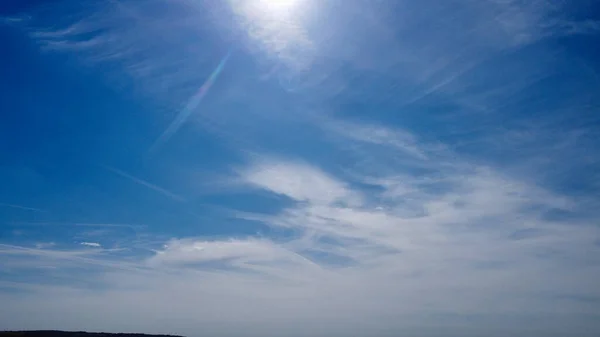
[2,122,600,335]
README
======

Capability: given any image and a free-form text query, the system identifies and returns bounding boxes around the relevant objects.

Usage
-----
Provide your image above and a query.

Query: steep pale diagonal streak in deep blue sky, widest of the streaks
[148,51,231,152]
